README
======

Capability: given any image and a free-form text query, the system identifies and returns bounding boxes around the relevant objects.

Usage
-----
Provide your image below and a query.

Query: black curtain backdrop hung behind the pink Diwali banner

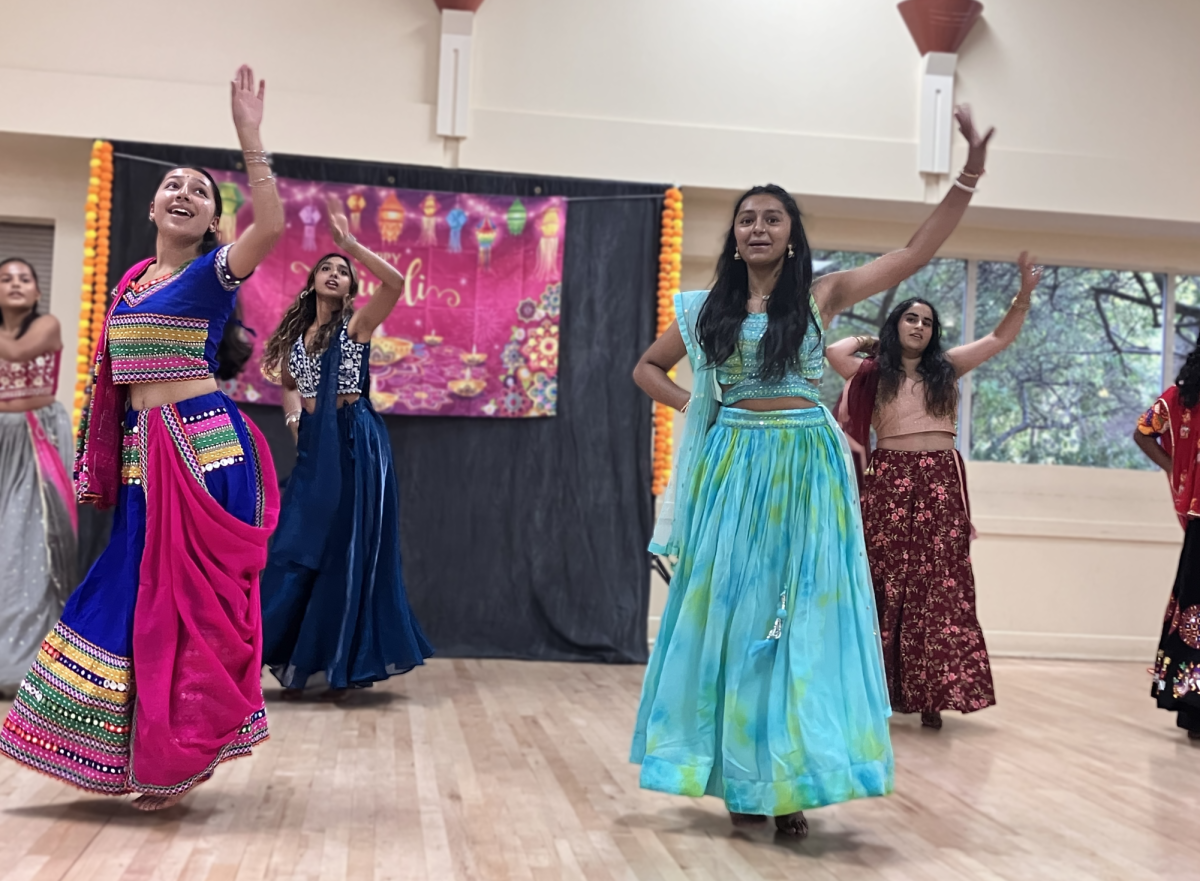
[80,142,666,663]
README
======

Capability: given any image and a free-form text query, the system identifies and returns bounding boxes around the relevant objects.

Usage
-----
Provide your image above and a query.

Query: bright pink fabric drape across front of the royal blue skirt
[130,404,280,795]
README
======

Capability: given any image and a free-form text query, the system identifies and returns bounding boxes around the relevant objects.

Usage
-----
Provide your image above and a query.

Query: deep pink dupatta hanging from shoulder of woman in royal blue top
[74,257,155,510]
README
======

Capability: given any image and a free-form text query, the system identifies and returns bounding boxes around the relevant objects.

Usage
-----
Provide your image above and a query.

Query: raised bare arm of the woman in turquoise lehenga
[812,104,996,325]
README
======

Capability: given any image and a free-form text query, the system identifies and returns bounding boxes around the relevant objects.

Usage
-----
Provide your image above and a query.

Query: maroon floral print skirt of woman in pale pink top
[863,450,996,713]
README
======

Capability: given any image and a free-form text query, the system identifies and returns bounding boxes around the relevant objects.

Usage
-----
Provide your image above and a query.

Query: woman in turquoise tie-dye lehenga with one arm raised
[631,108,991,835]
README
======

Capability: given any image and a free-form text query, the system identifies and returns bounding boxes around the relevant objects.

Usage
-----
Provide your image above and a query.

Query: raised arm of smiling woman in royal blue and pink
[229,65,283,278]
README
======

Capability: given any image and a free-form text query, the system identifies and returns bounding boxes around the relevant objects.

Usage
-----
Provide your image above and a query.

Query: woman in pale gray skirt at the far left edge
[0,257,77,696]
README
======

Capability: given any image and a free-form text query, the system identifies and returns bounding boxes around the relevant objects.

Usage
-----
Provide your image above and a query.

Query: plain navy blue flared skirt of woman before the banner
[262,397,433,689]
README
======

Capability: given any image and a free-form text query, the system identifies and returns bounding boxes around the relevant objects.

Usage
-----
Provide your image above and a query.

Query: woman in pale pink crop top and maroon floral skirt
[826,253,1042,729]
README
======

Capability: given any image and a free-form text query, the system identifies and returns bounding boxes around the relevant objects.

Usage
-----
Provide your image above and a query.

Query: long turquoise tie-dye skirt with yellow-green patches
[631,407,893,816]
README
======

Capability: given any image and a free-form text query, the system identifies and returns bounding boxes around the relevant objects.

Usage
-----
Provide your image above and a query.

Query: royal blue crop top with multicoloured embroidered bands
[108,245,244,384]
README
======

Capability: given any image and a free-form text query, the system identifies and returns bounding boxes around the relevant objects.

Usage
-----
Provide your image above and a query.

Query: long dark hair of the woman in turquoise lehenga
[697,184,814,380]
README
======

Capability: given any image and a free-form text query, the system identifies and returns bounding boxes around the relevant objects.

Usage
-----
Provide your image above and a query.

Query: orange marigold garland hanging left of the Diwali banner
[71,140,113,432]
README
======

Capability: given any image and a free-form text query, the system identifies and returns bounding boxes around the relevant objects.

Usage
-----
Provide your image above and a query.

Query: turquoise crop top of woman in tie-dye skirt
[716,296,824,406]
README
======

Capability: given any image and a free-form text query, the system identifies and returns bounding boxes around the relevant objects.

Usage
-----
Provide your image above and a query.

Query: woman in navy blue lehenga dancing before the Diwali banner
[262,200,433,700]
